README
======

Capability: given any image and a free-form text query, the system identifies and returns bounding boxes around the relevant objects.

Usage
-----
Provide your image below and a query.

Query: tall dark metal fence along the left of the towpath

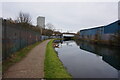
[2,20,41,59]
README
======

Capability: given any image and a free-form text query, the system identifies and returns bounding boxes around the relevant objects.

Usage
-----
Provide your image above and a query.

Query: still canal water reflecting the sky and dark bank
[55,40,120,78]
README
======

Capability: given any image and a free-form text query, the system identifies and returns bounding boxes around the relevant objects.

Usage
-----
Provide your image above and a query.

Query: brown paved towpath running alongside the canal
[3,40,49,78]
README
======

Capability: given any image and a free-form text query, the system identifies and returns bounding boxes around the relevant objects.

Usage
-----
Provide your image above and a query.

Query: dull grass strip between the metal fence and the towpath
[2,42,41,73]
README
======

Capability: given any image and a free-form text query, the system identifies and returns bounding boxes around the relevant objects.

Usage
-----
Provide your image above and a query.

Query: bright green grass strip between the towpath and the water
[44,39,72,79]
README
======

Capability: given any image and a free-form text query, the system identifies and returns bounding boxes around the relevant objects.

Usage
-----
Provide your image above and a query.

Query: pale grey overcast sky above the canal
[2,2,118,32]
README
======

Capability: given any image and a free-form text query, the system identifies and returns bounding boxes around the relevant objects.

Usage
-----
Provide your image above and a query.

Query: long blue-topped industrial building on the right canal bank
[80,20,120,41]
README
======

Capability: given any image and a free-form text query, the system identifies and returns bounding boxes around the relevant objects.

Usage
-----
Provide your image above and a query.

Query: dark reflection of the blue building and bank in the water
[76,41,120,70]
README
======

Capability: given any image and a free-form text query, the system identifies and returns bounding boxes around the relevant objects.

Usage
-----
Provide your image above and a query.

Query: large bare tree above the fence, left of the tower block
[17,12,31,24]
